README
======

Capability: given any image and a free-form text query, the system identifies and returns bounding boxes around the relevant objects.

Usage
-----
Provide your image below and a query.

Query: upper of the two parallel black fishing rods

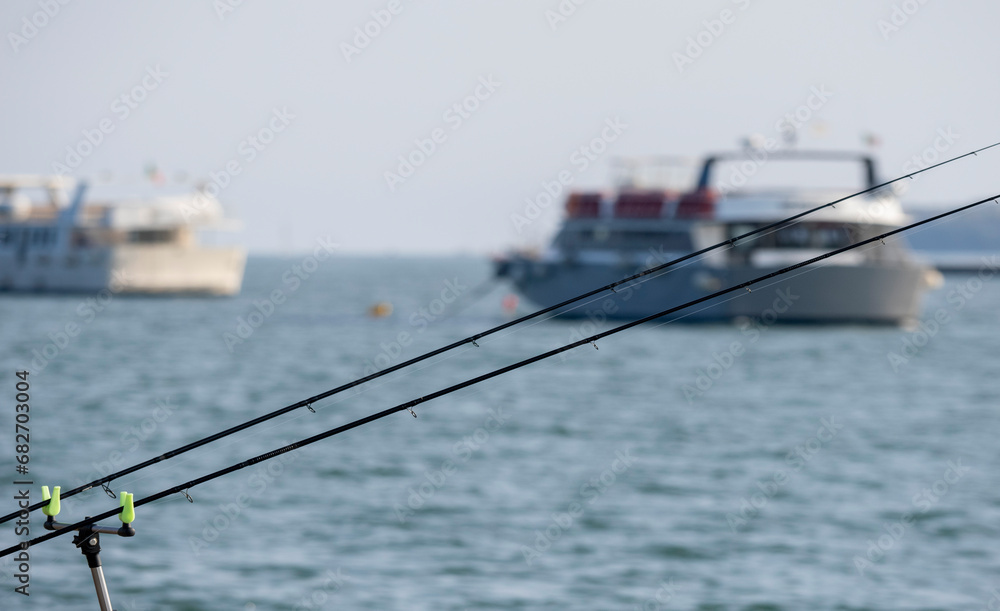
[0,142,1000,524]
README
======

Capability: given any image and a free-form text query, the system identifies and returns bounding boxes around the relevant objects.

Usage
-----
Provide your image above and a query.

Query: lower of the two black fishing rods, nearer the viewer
[0,193,1000,558]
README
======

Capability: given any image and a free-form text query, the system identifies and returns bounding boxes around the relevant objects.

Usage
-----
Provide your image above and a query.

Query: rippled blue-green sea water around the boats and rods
[0,258,1000,611]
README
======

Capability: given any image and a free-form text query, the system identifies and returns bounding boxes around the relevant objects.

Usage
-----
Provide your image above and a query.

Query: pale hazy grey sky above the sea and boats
[0,0,1000,253]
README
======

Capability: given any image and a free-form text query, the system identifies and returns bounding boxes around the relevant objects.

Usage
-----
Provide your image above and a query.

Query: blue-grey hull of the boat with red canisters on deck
[504,259,930,325]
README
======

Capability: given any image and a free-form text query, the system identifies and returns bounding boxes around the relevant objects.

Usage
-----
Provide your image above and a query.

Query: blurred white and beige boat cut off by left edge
[0,176,246,295]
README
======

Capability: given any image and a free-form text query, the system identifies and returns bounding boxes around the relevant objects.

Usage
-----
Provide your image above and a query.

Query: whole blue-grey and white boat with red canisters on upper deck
[497,151,939,324]
